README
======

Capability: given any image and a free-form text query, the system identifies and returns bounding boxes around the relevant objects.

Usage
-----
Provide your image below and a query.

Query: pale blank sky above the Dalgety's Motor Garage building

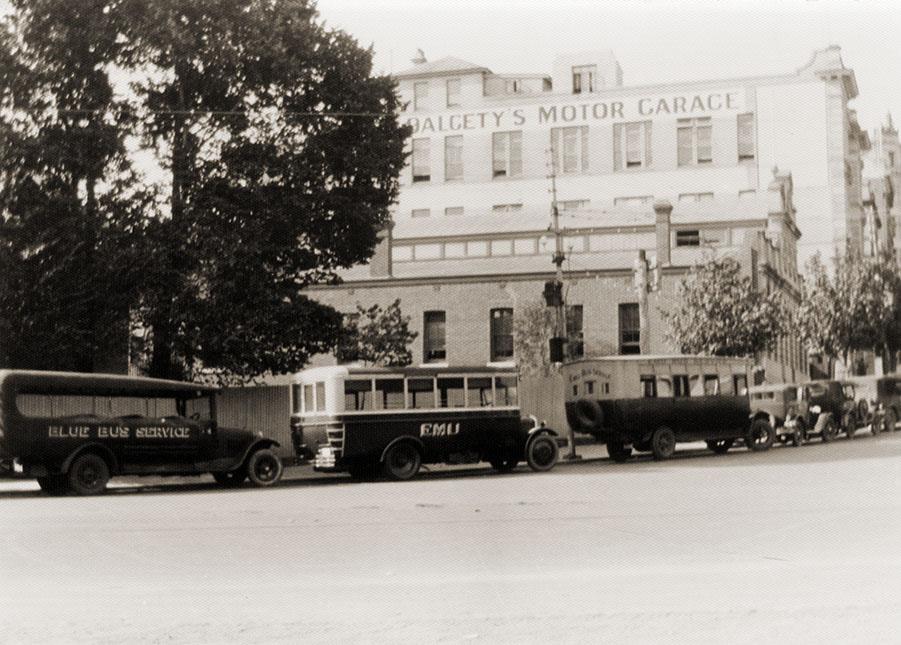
[317,0,901,130]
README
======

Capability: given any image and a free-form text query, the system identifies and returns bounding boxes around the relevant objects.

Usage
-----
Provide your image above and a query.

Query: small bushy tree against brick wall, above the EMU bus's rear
[336,300,419,367]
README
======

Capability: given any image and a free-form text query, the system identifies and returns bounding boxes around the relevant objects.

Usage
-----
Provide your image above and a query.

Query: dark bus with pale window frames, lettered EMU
[291,366,565,480]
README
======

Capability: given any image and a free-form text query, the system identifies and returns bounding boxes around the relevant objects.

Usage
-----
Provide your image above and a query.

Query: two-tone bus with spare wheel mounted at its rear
[562,355,775,462]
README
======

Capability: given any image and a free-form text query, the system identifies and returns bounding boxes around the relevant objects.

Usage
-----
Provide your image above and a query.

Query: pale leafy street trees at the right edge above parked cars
[798,250,901,369]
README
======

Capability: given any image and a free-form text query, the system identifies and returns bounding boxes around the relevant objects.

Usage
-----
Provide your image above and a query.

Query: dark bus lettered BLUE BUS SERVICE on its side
[0,370,282,495]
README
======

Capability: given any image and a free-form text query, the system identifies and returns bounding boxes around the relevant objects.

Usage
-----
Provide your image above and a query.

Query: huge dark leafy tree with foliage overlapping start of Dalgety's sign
[0,0,407,378]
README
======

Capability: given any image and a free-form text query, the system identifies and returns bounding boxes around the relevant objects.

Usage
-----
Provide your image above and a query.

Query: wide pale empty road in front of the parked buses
[0,432,901,643]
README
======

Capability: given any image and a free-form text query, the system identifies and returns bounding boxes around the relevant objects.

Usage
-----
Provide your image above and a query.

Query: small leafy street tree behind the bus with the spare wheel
[661,257,791,357]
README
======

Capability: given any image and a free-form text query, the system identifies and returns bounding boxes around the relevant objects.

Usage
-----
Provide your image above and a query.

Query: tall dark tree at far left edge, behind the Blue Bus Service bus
[0,0,146,370]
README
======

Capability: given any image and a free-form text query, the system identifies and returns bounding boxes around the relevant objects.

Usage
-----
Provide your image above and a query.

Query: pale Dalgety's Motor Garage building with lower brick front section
[306,47,868,381]
